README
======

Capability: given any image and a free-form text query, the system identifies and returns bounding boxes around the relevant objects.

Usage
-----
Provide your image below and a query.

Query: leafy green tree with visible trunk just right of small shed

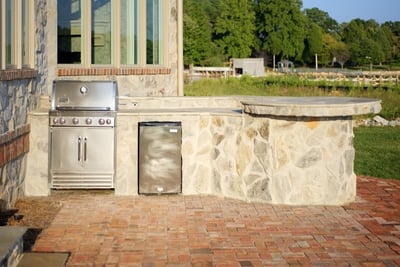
[255,0,306,68]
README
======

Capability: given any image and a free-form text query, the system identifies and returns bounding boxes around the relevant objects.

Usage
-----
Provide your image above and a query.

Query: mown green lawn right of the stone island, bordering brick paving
[354,127,400,180]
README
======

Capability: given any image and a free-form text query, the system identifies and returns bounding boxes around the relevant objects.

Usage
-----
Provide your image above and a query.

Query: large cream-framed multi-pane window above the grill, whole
[57,0,166,67]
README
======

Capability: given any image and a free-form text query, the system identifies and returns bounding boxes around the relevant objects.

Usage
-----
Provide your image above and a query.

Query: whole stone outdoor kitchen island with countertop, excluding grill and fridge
[25,96,381,205]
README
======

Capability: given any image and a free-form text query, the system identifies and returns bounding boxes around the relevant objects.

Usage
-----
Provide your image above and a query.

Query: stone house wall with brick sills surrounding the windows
[0,0,183,208]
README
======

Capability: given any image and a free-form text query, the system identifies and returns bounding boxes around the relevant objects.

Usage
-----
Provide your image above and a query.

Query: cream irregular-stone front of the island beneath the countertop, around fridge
[116,111,356,205]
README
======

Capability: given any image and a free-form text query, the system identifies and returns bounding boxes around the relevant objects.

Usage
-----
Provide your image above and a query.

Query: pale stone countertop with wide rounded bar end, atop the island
[29,96,382,117]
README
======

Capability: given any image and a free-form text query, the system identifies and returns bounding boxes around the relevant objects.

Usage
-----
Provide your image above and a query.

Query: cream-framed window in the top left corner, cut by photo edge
[0,0,34,69]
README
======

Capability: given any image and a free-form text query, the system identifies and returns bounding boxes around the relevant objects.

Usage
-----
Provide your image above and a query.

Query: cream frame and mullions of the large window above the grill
[57,0,169,68]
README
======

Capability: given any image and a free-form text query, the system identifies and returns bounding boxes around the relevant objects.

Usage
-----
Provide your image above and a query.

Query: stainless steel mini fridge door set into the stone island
[138,122,182,194]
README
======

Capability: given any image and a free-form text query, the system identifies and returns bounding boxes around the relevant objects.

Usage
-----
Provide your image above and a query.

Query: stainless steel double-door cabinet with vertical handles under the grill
[49,127,115,188]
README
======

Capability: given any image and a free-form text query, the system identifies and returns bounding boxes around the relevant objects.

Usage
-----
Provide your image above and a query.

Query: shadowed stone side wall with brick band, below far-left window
[0,79,32,209]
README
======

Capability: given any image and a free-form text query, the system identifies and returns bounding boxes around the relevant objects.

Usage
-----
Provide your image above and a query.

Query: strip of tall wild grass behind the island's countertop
[184,75,400,120]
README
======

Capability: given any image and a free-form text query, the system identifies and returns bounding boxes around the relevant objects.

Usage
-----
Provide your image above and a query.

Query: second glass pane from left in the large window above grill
[92,0,112,64]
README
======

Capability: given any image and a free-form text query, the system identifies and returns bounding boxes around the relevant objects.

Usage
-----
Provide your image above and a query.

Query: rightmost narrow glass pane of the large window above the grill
[146,0,163,64]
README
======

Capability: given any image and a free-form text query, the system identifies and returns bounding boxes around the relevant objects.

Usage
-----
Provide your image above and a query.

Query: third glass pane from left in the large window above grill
[120,0,139,64]
